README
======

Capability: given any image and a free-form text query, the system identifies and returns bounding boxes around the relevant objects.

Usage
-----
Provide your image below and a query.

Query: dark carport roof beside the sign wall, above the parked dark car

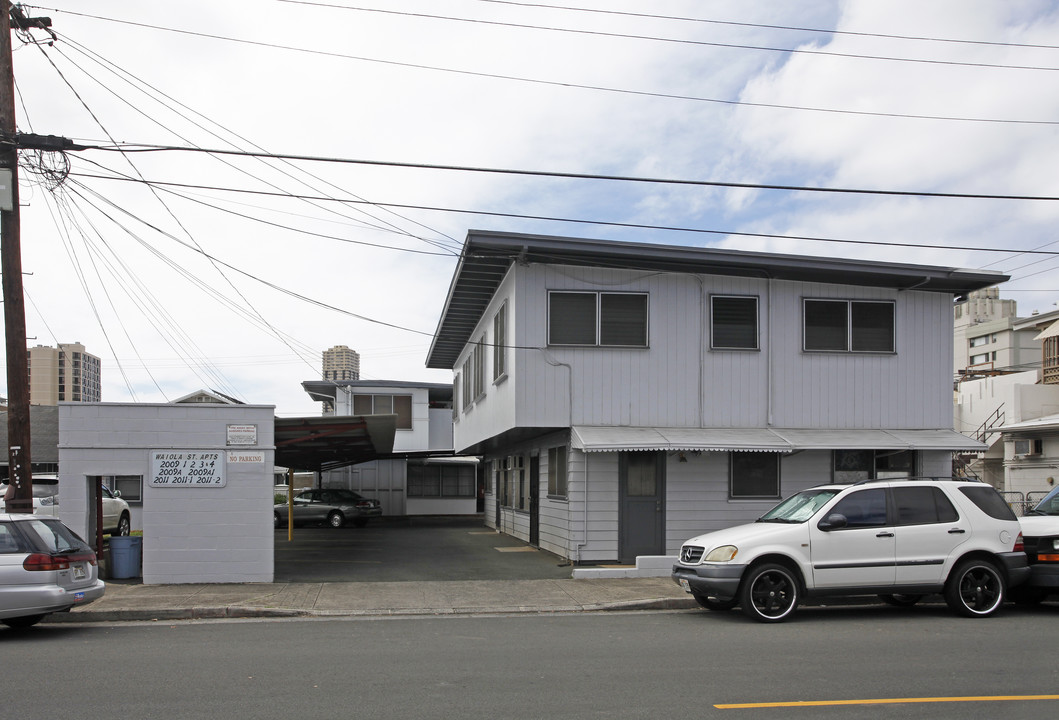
[275,415,397,471]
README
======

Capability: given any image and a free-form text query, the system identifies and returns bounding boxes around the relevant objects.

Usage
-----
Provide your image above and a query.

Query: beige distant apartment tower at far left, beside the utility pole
[28,342,103,406]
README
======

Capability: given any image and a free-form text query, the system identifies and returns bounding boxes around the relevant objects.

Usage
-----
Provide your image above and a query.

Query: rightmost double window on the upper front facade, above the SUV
[804,300,894,353]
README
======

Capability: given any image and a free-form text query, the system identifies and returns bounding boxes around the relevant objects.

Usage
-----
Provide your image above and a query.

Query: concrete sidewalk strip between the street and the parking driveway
[43,577,698,623]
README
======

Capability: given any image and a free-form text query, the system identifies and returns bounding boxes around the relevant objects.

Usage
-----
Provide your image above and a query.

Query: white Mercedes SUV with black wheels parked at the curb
[672,479,1029,623]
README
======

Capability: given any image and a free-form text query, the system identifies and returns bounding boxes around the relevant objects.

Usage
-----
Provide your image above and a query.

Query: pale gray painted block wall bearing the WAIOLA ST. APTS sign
[59,403,275,584]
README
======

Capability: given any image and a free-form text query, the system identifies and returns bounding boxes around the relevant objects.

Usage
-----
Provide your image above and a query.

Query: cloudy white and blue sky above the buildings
[6,0,1059,416]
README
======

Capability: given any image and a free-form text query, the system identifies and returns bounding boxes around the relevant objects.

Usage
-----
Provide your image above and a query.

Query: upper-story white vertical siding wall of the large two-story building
[455,265,952,449]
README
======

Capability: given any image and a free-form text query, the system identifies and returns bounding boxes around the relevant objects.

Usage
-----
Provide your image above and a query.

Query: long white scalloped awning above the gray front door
[573,426,986,452]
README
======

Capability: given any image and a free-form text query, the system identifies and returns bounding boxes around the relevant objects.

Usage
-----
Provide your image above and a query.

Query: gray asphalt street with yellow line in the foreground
[8,606,1059,720]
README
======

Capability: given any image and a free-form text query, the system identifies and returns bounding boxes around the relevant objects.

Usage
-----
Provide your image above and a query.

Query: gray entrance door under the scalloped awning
[617,452,665,564]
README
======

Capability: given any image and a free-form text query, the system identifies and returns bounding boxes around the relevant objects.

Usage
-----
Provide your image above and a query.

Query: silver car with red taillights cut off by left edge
[0,512,106,628]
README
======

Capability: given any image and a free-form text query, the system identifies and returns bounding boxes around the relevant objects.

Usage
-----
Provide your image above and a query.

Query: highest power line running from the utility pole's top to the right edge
[37,11,1059,126]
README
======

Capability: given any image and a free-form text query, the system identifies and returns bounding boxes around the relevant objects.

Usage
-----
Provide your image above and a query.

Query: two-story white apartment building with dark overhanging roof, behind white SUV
[427,231,1006,563]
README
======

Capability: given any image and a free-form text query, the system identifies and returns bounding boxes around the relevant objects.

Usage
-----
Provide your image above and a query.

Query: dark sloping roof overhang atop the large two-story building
[427,230,1009,370]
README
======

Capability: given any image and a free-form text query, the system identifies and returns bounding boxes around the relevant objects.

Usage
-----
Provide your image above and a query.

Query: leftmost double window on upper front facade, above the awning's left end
[548,292,647,347]
